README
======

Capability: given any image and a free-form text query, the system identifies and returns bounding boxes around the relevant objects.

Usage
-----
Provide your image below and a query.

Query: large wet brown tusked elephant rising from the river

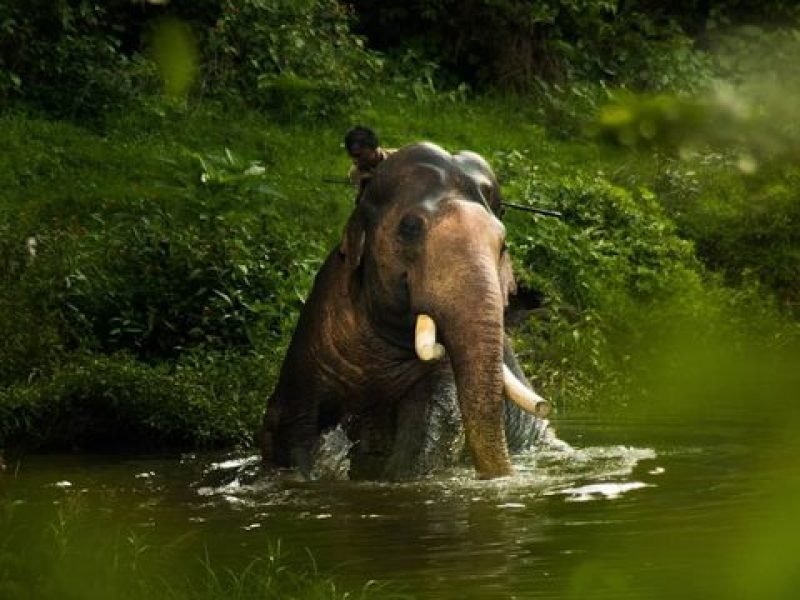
[260,142,549,480]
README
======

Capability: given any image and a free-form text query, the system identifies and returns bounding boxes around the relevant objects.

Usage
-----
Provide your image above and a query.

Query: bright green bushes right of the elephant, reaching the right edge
[506,141,800,411]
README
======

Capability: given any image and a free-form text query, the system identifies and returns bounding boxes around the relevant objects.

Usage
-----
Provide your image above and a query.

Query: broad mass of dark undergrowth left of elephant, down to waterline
[0,145,314,449]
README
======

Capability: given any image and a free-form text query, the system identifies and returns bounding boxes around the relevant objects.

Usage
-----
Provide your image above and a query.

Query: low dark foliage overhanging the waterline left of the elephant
[0,353,268,451]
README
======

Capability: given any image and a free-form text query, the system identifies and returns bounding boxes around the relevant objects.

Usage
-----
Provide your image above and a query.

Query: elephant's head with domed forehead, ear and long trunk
[342,143,535,478]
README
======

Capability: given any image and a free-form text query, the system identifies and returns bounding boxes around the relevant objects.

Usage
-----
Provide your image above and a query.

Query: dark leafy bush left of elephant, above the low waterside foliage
[9,204,292,360]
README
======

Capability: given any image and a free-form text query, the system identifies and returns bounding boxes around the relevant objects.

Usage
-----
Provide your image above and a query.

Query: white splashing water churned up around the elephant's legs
[193,420,663,510]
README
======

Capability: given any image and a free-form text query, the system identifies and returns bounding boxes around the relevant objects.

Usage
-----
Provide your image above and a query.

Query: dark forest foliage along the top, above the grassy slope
[0,0,798,124]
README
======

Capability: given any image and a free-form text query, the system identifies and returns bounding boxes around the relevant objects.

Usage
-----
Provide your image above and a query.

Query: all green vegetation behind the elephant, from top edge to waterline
[0,0,800,460]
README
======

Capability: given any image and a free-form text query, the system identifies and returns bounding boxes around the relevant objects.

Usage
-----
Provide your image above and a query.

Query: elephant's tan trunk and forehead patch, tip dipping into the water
[407,201,512,479]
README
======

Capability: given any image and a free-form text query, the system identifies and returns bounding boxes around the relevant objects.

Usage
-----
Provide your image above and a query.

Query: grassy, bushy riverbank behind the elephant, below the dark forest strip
[0,89,800,451]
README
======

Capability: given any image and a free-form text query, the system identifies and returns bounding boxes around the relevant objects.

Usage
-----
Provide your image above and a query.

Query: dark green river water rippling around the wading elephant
[0,420,800,598]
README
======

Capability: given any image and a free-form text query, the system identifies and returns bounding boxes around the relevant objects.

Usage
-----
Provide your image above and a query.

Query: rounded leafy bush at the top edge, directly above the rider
[205,0,382,120]
